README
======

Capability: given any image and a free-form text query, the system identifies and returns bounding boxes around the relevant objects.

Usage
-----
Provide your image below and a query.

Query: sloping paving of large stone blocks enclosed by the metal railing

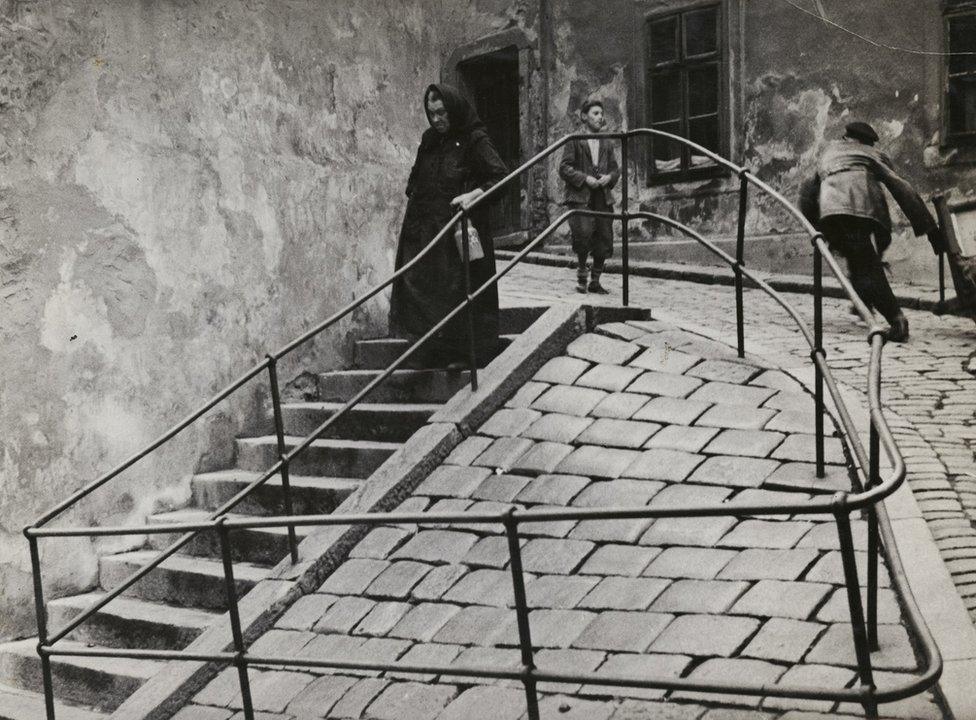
[183,322,943,720]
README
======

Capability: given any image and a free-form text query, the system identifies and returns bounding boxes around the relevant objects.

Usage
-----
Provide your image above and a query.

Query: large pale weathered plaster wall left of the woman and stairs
[0,0,441,638]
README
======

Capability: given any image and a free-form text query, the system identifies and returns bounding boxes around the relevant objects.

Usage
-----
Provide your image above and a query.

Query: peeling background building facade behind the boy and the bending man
[443,0,976,286]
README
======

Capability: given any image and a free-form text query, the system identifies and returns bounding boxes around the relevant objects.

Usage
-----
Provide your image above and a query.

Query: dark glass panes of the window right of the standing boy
[645,5,725,182]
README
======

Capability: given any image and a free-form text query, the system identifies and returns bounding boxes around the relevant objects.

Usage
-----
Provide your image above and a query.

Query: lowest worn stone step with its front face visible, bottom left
[0,638,157,720]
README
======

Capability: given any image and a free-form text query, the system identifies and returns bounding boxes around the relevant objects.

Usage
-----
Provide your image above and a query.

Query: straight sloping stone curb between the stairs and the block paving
[111,304,616,720]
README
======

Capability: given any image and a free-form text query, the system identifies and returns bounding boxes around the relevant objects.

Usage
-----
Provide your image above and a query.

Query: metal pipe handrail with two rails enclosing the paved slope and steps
[25,128,941,718]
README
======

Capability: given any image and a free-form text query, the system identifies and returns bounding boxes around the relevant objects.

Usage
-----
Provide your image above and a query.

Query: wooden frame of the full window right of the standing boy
[640,0,731,186]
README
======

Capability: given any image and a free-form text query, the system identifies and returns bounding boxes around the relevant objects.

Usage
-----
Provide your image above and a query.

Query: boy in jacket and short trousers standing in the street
[559,100,620,295]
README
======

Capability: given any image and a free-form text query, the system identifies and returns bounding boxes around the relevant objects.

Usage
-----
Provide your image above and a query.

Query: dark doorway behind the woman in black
[457,47,522,238]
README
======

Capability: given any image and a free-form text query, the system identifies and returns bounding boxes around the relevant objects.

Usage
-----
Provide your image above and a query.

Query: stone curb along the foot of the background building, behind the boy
[498,251,967,317]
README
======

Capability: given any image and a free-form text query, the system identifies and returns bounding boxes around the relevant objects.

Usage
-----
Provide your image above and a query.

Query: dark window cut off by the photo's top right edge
[944,9,976,144]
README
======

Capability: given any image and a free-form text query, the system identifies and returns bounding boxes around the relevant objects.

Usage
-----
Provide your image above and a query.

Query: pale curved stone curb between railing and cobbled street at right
[658,317,976,720]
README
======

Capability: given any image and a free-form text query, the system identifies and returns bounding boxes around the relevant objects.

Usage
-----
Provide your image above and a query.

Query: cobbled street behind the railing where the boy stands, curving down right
[502,265,976,622]
